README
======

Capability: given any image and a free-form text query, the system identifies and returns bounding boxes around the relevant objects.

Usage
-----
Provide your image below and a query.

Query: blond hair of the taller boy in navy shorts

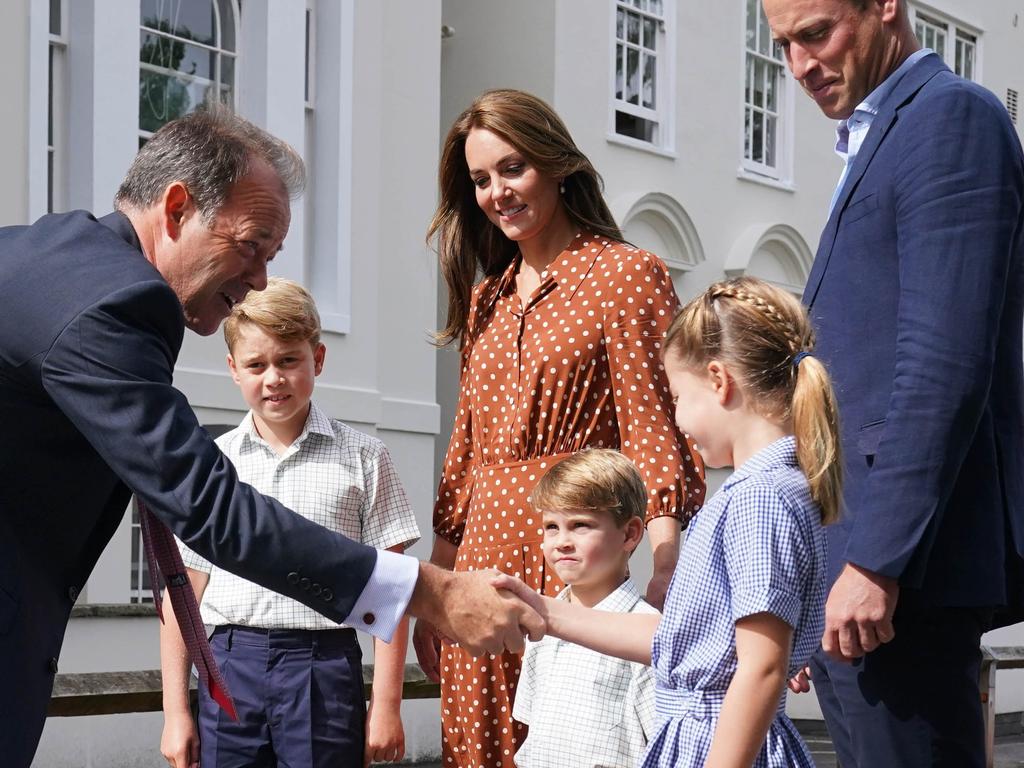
[224,278,321,351]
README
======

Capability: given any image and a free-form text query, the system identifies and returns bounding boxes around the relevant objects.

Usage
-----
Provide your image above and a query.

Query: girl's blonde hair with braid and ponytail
[664,278,842,524]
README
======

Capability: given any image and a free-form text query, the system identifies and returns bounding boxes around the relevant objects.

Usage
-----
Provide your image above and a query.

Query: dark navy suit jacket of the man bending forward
[0,211,376,766]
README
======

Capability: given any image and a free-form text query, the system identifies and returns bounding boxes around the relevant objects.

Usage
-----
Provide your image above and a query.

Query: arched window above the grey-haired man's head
[138,0,238,145]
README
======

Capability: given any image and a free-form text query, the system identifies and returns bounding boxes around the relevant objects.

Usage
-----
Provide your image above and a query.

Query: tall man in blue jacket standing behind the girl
[764,0,1024,768]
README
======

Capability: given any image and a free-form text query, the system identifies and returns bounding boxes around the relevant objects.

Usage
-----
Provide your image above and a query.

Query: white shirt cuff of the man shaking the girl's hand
[345,550,420,643]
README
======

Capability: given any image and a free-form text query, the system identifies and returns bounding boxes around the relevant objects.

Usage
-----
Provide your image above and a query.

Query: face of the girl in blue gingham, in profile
[665,352,735,468]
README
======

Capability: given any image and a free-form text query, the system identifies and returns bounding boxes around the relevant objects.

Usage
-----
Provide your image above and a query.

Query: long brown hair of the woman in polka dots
[427,89,623,345]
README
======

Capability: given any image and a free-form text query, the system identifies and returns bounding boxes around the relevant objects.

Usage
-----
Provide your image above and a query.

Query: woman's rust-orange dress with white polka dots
[434,234,705,768]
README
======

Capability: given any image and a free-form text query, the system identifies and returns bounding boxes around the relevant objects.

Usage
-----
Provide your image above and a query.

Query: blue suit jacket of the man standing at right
[804,54,1024,606]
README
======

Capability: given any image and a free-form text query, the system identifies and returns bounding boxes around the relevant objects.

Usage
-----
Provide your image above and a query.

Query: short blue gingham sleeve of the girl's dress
[722,481,807,628]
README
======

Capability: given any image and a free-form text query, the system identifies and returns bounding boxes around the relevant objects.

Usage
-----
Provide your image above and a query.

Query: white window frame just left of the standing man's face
[738,0,796,185]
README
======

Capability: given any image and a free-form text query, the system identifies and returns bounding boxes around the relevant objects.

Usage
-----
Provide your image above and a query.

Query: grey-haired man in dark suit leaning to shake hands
[0,109,543,768]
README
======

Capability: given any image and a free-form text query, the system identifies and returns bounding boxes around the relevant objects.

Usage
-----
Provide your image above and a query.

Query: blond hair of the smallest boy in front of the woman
[530,449,647,527]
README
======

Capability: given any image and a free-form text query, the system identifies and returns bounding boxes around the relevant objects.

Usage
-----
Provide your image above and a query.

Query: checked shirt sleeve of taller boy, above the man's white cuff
[361,440,420,549]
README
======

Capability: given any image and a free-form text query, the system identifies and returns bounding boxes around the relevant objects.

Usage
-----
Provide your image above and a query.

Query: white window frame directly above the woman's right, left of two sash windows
[607,0,678,157]
